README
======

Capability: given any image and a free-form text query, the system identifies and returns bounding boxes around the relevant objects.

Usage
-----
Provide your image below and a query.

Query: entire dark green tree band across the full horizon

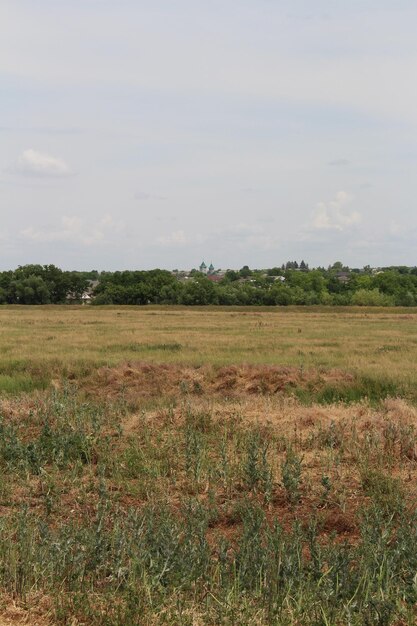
[0,261,417,306]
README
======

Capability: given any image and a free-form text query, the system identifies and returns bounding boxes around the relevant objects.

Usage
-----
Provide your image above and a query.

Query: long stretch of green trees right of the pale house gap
[93,261,417,306]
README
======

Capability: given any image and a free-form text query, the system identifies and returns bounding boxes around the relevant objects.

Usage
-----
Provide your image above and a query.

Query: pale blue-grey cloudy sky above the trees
[0,0,417,270]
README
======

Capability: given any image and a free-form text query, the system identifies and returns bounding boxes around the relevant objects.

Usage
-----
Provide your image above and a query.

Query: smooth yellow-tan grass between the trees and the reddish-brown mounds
[0,306,417,391]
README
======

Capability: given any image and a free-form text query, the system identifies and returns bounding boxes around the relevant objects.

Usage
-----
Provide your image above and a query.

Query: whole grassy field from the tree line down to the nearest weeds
[0,306,417,626]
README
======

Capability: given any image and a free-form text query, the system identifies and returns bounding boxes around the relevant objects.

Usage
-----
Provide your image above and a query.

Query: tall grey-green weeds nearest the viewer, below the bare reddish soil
[0,491,417,626]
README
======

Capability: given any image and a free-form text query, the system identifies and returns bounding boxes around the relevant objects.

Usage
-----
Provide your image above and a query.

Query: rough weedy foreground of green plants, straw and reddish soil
[0,387,417,625]
